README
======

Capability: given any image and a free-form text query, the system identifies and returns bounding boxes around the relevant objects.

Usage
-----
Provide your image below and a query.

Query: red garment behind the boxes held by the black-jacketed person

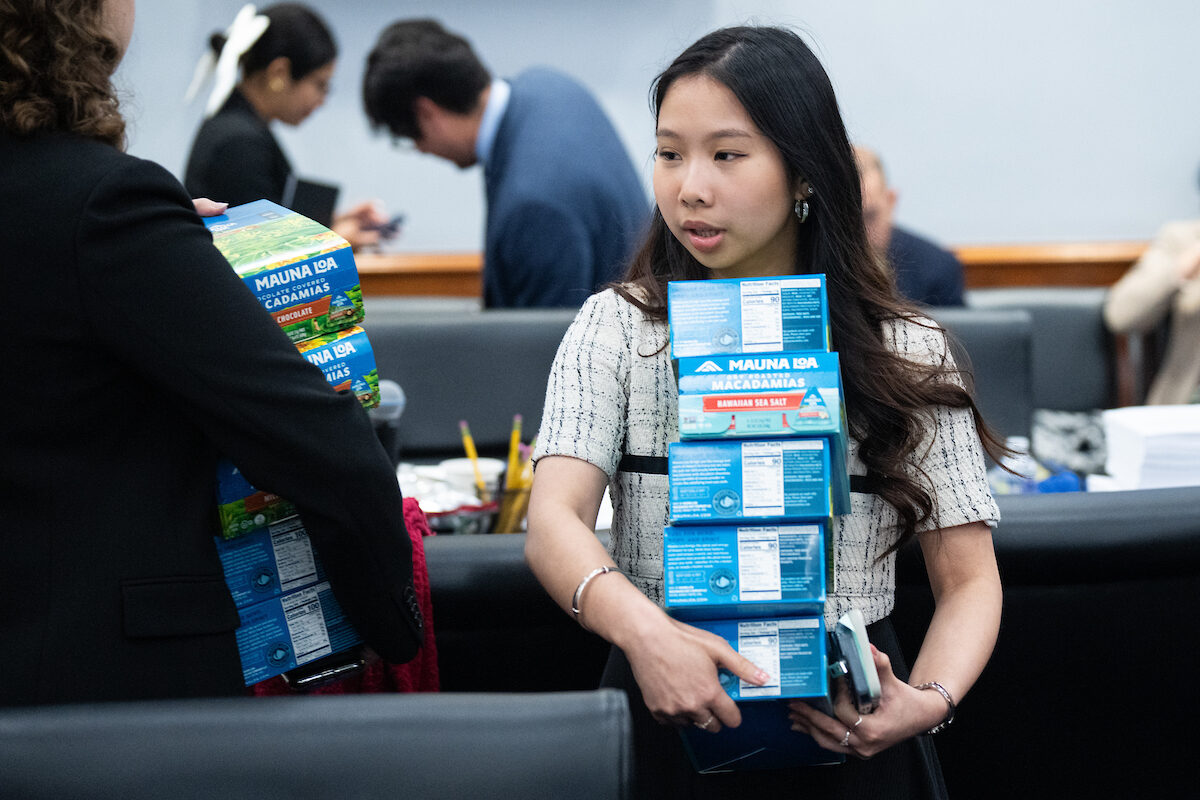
[250,498,438,697]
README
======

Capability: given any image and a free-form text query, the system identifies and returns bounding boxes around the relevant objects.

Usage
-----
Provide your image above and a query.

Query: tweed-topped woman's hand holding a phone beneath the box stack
[788,644,946,758]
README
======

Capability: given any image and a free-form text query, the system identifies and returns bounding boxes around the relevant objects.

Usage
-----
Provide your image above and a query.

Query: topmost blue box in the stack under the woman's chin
[667,275,830,359]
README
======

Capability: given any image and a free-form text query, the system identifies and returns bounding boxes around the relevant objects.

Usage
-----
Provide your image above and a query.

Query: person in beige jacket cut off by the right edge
[1104,219,1200,405]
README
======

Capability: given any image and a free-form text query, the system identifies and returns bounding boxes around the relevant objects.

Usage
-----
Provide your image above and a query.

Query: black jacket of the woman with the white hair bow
[184,89,292,205]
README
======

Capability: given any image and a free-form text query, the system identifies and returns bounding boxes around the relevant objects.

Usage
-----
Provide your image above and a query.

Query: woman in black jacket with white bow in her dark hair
[184,2,388,249]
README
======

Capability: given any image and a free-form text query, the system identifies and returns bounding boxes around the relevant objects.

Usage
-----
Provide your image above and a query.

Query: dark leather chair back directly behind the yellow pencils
[362,299,577,461]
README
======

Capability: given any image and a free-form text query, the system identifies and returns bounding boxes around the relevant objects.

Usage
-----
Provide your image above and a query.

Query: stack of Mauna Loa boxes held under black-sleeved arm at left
[205,200,379,686]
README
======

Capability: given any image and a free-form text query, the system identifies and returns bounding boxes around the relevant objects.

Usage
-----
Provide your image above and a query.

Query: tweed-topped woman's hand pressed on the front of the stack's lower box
[625,612,770,733]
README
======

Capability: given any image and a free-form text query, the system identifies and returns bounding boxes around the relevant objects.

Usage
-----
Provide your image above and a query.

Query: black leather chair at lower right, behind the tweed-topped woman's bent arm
[893,487,1200,800]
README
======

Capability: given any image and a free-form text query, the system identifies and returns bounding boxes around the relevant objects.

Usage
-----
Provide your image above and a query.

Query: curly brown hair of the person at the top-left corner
[0,0,125,148]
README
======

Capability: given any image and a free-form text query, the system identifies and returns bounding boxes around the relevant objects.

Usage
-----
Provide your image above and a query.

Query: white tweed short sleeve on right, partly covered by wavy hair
[888,320,1000,530]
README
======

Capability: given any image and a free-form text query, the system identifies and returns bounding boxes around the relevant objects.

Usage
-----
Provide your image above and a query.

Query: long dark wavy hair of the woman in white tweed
[613,26,1003,547]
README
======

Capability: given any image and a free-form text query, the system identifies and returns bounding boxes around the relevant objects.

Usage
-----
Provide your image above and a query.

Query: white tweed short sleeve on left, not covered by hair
[534,289,630,477]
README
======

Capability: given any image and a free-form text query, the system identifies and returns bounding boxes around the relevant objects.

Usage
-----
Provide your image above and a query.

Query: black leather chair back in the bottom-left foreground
[0,690,631,800]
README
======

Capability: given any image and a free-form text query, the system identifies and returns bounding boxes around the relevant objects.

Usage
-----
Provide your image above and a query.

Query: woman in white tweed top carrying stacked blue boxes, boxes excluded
[526,28,1001,800]
